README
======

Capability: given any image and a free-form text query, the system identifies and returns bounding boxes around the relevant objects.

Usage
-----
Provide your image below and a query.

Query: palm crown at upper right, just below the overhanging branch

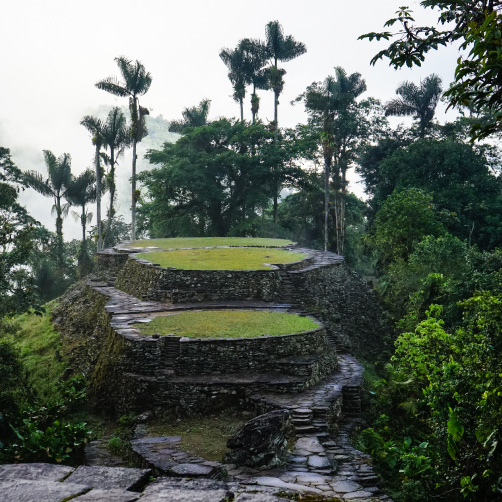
[385,73,443,138]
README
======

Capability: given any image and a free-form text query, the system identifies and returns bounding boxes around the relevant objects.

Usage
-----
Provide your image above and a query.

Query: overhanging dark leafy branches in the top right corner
[359,0,502,139]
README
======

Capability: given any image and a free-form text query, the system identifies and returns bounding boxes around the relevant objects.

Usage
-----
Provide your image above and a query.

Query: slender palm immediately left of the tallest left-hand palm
[101,106,131,247]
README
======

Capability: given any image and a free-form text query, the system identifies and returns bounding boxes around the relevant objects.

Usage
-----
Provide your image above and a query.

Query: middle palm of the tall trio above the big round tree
[239,38,268,124]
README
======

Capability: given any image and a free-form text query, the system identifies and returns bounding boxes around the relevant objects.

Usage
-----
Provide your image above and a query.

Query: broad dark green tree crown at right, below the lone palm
[360,138,502,249]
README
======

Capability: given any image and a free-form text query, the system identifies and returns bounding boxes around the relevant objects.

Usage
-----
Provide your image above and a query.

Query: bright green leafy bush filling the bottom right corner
[361,293,502,501]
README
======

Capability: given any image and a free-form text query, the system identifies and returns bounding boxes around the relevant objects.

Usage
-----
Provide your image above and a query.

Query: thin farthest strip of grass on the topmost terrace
[128,237,294,249]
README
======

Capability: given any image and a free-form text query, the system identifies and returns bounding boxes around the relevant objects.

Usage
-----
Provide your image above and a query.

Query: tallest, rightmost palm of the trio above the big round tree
[265,21,307,133]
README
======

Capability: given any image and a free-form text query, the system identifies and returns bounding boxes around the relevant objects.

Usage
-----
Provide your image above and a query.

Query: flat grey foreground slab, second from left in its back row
[63,465,152,490]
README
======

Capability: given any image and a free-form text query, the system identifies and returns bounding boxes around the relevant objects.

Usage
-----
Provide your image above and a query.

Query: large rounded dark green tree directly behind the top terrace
[140,119,302,237]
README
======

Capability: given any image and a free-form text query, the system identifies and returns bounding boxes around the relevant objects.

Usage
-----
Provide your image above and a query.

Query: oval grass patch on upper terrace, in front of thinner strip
[136,248,307,270]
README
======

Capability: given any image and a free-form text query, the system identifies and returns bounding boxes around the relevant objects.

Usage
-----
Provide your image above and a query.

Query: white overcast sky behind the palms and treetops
[0,0,457,239]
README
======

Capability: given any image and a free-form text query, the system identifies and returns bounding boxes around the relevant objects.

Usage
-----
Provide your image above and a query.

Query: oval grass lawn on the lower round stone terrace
[134,310,319,338]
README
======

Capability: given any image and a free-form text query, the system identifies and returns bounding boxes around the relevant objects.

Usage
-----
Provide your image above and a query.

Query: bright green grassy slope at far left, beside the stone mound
[10,301,66,400]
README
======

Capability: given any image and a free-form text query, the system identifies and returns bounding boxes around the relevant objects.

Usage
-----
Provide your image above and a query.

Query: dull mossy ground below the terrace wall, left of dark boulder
[148,409,251,461]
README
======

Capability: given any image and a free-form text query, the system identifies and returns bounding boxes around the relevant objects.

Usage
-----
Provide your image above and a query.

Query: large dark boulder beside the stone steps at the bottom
[223,410,291,469]
